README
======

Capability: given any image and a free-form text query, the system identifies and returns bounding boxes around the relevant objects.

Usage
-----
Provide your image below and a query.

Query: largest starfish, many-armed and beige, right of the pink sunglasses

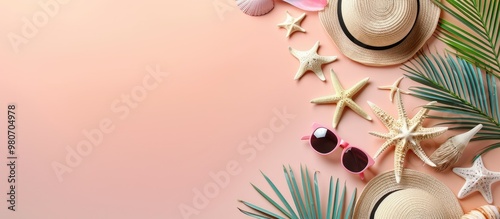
[368,91,448,183]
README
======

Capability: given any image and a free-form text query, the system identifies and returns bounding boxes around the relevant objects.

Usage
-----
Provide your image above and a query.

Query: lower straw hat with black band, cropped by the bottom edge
[353,169,463,219]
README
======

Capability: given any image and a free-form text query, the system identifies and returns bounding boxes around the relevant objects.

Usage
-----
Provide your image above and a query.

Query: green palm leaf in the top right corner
[434,0,500,78]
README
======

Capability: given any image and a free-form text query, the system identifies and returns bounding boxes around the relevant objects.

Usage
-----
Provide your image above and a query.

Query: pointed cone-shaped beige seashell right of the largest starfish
[430,124,483,171]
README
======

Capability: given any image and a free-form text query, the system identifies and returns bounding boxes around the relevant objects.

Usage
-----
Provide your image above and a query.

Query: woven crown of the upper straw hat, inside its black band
[341,0,419,47]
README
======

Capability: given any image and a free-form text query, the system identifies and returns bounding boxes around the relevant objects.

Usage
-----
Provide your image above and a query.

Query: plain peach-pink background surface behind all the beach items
[0,0,500,219]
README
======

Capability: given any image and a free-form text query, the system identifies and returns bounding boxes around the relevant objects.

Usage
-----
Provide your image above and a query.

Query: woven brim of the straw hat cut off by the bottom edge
[352,169,463,219]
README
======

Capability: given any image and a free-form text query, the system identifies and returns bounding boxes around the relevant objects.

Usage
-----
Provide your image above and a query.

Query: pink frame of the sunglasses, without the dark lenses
[300,123,375,180]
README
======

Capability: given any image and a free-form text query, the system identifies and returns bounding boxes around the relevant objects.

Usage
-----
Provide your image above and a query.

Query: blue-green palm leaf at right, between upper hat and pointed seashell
[403,53,500,159]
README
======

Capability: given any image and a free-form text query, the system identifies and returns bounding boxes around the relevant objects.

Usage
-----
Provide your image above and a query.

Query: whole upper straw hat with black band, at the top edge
[319,0,441,66]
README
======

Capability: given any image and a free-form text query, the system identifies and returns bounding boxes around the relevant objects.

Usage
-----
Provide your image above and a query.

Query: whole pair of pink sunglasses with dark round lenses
[301,123,375,180]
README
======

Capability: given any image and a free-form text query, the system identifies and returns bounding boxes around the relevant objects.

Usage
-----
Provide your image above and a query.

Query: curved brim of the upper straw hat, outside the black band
[319,0,441,66]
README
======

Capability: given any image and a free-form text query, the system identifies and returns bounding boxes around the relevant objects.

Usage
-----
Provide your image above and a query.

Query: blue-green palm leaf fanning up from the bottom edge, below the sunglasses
[238,166,356,219]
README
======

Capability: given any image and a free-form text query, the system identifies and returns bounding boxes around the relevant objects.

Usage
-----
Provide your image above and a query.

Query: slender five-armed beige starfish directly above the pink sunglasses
[311,69,372,128]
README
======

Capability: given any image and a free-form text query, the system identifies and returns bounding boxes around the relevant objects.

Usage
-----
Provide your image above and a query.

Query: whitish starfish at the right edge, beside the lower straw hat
[453,157,500,204]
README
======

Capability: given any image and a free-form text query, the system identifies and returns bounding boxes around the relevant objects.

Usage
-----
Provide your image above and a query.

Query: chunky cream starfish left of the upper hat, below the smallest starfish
[288,41,337,81]
